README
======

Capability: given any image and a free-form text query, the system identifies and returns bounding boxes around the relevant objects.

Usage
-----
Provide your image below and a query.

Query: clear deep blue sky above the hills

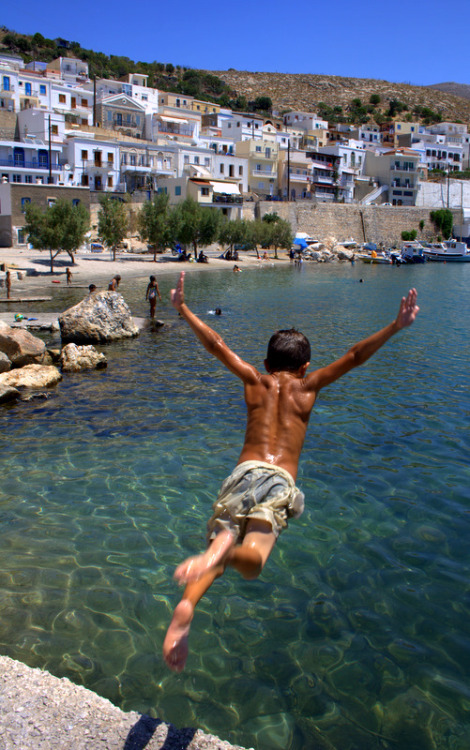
[0,0,470,85]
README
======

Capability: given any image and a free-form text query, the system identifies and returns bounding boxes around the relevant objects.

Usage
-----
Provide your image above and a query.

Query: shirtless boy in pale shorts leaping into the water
[163,272,419,672]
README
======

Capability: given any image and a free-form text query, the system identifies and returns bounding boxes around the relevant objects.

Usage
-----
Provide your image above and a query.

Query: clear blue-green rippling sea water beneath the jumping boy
[0,264,470,750]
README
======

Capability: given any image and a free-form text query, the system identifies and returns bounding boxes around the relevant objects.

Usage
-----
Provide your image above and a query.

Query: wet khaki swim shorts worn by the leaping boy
[207,461,304,541]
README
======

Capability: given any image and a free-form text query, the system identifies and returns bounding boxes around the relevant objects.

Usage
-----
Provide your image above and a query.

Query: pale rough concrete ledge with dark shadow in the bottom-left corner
[0,656,250,750]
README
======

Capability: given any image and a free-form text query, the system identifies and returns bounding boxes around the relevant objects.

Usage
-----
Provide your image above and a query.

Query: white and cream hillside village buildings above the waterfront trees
[0,36,470,247]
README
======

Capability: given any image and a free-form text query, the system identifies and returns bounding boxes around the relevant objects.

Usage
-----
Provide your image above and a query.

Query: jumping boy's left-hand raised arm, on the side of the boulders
[171,271,260,383]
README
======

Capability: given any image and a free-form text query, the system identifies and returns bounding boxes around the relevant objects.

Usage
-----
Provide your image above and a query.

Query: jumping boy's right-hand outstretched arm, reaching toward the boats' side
[305,289,419,391]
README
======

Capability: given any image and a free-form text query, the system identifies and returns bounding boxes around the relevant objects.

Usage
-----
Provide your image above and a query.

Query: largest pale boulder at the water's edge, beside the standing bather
[59,292,139,344]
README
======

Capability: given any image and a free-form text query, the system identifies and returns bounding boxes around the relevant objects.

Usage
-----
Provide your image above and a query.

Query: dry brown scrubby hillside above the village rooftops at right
[211,70,470,122]
